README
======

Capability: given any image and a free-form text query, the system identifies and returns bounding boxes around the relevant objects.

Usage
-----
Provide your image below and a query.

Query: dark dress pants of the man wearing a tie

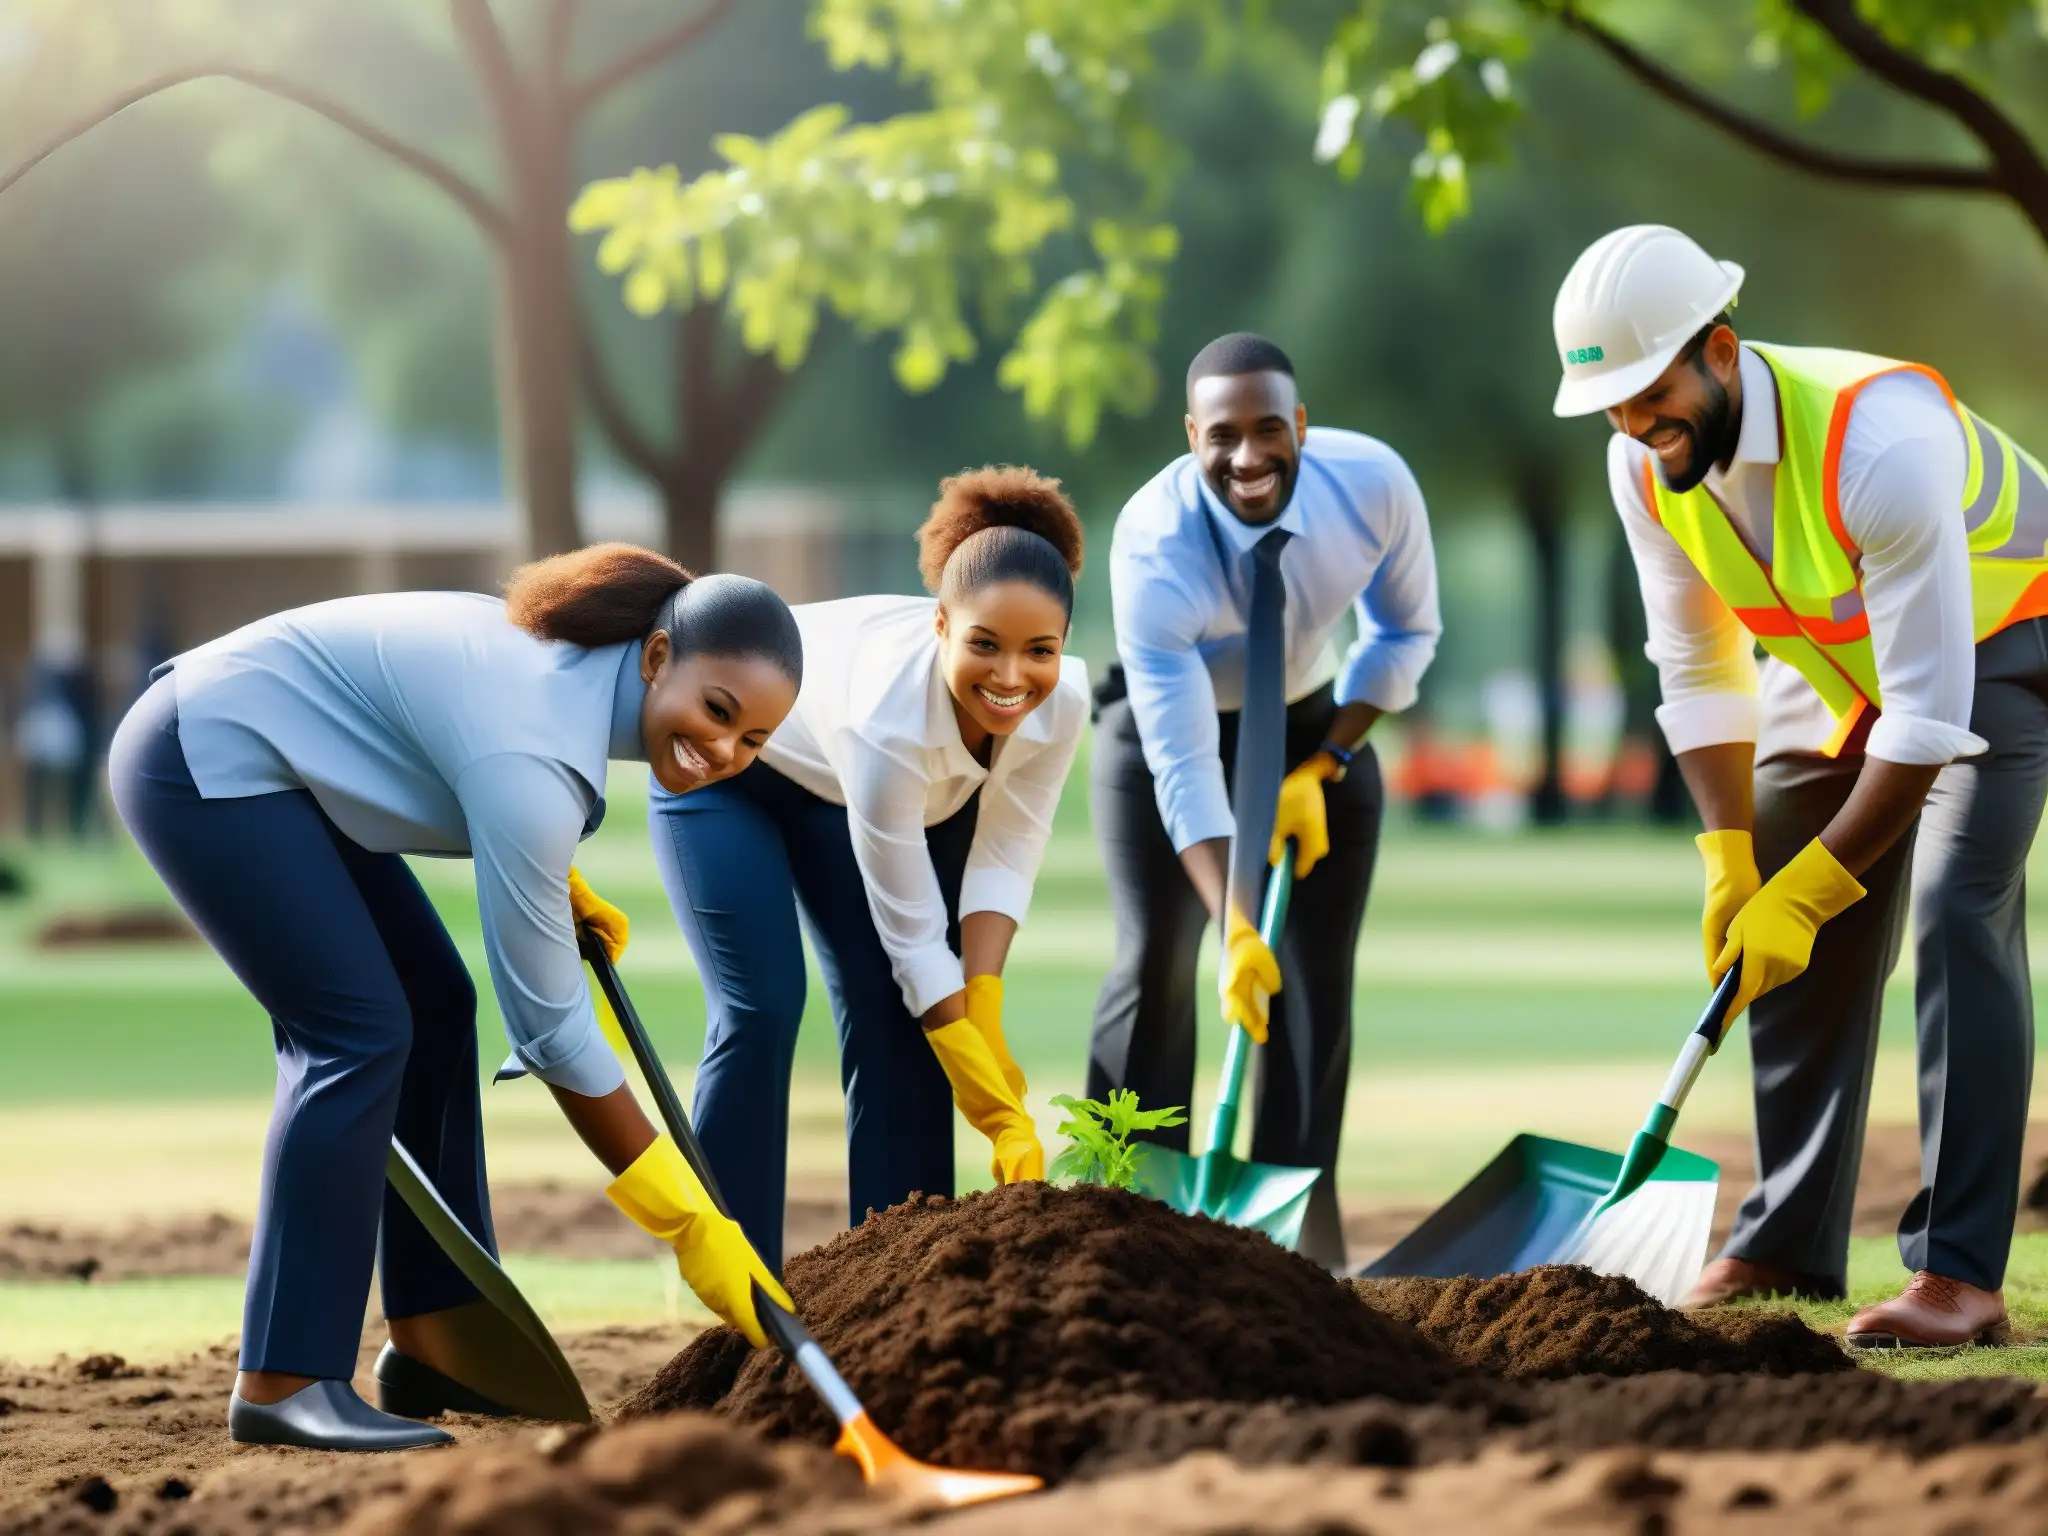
[1087,686,1380,1268]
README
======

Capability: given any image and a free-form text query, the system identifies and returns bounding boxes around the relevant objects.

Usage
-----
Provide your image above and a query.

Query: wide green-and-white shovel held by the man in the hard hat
[1358,967,1741,1307]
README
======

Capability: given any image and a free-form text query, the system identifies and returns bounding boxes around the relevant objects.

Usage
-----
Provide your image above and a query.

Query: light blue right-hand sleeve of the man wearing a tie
[1337,455,1444,715]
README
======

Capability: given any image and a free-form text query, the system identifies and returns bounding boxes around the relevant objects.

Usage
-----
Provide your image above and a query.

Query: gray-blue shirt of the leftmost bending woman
[166,592,647,1096]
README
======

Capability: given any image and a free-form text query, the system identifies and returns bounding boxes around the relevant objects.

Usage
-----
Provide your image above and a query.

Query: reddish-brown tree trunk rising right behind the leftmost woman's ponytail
[498,123,584,559]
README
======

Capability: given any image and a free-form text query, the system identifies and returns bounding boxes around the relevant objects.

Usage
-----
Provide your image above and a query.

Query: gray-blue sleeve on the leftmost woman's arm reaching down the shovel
[455,754,625,1098]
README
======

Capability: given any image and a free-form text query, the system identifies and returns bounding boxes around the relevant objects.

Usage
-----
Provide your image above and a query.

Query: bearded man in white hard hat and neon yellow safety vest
[1552,225,2048,1346]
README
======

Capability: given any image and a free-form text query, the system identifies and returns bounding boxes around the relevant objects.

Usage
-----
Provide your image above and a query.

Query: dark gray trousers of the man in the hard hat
[1722,621,2048,1296]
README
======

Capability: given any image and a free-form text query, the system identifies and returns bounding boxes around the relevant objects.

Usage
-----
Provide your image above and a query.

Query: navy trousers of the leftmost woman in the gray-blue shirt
[106,676,498,1380]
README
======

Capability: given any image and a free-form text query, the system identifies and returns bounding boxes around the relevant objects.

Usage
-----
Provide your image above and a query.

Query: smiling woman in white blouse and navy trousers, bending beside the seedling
[649,467,1087,1268]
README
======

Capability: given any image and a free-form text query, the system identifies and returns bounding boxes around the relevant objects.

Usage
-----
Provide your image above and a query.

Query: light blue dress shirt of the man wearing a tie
[1110,426,1444,852]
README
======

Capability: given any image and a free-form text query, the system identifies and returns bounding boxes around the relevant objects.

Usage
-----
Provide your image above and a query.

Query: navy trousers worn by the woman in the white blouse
[647,764,979,1270]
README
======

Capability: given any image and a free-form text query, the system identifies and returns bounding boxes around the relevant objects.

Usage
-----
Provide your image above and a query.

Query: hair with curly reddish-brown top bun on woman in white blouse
[918,465,1083,618]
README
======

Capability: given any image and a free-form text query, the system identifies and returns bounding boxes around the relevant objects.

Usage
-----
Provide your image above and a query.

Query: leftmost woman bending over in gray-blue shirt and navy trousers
[109,545,803,1450]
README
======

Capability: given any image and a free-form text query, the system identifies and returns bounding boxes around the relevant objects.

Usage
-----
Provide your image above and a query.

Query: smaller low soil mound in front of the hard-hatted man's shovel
[1352,1264,1855,1382]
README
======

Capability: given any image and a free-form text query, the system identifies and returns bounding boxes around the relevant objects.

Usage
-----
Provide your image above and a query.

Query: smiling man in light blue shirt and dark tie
[1087,332,1442,1268]
